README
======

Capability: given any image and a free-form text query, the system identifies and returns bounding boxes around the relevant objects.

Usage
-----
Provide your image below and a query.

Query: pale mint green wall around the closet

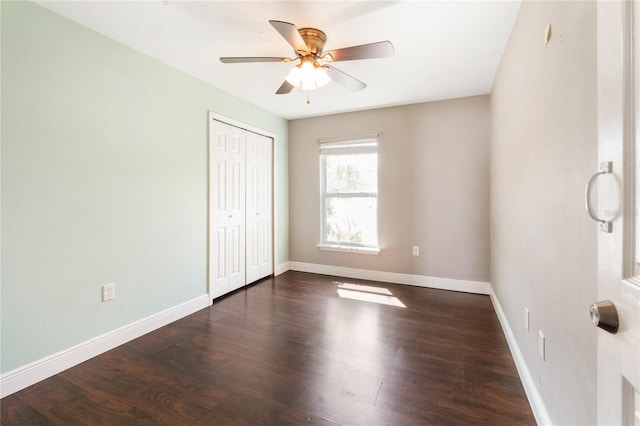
[0,1,288,372]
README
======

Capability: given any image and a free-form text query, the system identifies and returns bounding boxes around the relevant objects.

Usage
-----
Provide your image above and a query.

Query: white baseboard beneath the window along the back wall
[289,262,491,294]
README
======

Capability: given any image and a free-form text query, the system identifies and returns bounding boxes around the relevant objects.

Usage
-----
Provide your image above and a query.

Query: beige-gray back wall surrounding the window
[289,96,490,282]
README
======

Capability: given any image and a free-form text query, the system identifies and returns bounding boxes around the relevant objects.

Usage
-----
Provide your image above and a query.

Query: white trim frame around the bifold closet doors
[207,111,278,300]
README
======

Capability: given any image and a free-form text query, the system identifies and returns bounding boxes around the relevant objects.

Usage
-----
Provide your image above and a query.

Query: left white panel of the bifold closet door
[209,120,246,299]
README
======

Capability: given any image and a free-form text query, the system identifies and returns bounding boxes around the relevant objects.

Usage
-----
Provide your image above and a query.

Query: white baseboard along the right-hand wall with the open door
[489,286,553,425]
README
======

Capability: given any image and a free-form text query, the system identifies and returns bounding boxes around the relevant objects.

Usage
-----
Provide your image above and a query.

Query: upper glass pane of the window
[326,153,378,193]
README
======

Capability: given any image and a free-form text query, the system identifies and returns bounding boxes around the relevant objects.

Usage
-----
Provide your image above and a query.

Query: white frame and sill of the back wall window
[318,137,380,254]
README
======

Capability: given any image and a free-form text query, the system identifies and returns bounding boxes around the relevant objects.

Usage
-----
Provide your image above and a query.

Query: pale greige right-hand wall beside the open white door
[491,1,597,424]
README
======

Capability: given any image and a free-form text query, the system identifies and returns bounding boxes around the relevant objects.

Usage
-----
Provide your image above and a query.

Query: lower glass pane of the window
[325,197,378,246]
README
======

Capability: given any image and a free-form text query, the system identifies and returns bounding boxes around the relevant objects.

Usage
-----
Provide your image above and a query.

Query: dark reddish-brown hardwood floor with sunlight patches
[0,272,535,426]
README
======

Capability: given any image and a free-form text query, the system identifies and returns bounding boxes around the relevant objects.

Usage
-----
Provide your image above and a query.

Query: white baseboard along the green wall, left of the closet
[0,294,211,398]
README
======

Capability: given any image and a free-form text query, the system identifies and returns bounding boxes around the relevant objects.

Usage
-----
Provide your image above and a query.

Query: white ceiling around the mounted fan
[38,0,520,119]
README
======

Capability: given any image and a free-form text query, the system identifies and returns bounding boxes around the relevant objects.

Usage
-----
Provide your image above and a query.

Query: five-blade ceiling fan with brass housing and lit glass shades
[220,20,394,95]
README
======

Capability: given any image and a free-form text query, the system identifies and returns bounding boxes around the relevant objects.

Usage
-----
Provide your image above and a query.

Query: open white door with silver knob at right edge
[592,1,640,425]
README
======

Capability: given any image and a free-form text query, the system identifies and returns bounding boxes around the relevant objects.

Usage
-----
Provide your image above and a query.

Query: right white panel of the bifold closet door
[247,132,273,283]
